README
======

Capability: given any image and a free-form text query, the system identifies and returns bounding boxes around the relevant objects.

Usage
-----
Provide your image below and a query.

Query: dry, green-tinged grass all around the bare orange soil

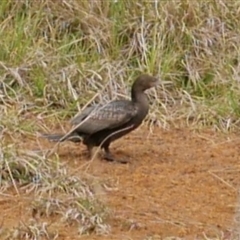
[0,0,240,239]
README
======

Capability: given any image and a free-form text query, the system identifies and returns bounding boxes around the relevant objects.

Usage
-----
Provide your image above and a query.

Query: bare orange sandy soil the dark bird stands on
[0,127,240,240]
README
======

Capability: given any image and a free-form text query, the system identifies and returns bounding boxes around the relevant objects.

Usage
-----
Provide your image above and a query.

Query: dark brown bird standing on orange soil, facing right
[42,74,159,163]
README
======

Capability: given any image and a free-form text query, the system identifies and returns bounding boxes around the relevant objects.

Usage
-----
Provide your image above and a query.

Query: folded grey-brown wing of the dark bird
[71,100,137,134]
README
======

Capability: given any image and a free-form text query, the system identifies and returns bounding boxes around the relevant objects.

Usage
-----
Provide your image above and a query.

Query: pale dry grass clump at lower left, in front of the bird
[0,135,110,236]
